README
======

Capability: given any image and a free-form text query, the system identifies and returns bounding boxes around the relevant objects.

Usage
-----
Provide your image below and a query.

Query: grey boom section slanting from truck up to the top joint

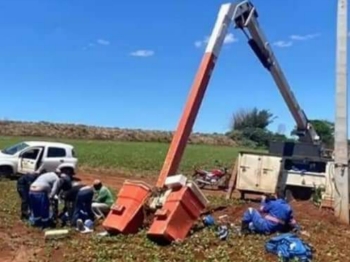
[233,1,319,143]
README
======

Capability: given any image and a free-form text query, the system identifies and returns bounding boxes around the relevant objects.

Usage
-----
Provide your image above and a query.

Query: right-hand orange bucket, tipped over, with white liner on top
[147,183,208,242]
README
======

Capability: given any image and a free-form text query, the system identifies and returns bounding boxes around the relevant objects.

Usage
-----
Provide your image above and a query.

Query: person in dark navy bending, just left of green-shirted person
[71,186,94,227]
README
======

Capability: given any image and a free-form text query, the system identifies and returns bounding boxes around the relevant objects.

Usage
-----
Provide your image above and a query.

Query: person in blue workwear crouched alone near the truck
[242,194,299,234]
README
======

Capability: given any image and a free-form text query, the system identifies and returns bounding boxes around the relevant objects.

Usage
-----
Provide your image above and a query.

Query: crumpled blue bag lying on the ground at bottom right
[265,233,313,262]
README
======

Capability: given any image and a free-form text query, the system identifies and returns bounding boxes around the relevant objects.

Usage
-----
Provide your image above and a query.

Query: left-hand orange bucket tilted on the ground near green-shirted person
[102,180,151,234]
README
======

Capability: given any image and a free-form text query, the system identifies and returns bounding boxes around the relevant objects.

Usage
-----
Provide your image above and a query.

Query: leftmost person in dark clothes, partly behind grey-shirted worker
[17,170,41,220]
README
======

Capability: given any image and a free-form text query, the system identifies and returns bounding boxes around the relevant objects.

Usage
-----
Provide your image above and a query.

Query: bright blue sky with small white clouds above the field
[0,0,344,135]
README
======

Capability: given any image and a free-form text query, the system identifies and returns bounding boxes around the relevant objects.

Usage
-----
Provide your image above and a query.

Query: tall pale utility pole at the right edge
[334,0,349,224]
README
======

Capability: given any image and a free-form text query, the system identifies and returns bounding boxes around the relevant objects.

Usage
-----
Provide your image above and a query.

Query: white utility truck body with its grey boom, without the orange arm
[223,1,334,205]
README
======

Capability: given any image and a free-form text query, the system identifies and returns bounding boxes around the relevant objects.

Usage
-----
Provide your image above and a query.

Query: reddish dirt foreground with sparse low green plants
[0,181,350,262]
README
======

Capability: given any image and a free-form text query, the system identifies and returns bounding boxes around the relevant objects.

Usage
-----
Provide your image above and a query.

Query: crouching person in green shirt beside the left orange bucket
[92,179,114,219]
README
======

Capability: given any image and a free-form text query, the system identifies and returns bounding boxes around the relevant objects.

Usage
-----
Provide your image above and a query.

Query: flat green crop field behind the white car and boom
[0,137,260,173]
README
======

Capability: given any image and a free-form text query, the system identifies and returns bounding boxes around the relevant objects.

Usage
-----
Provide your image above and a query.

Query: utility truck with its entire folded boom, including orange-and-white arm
[153,1,334,207]
